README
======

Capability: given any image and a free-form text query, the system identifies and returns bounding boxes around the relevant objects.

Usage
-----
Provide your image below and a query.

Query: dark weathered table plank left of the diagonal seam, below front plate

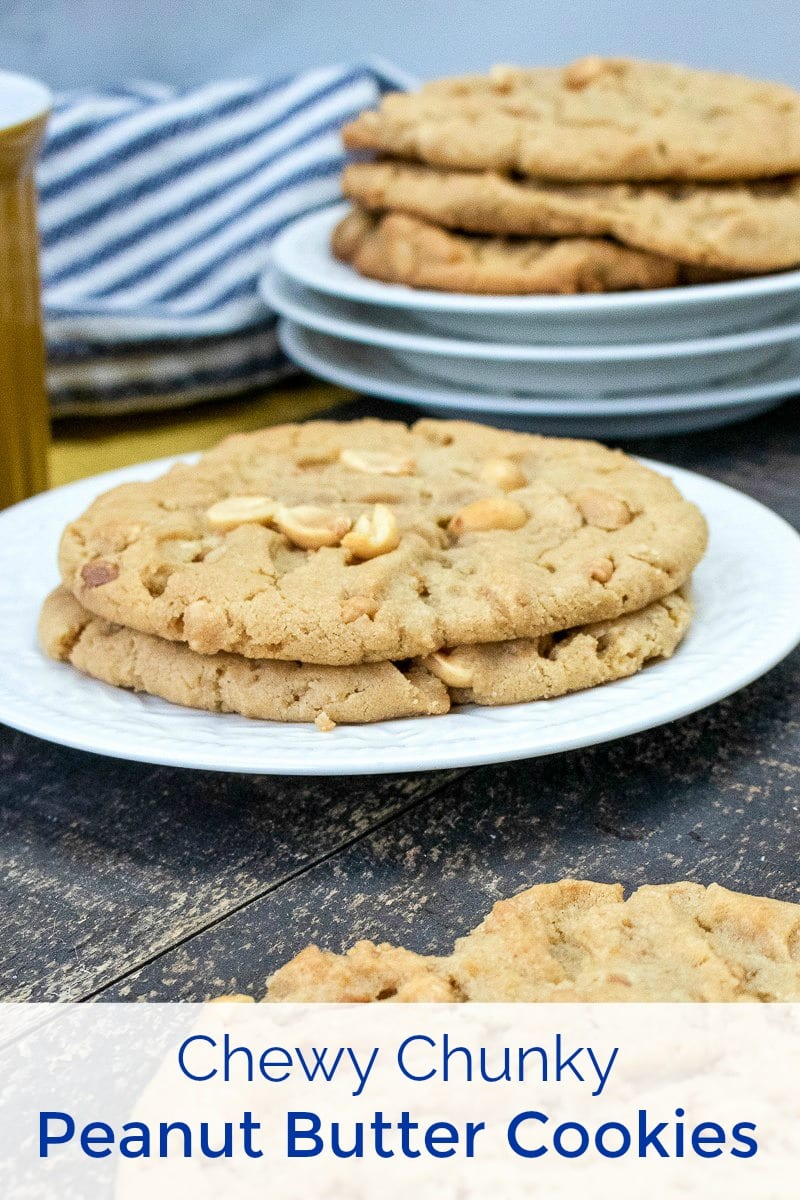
[0,727,462,1000]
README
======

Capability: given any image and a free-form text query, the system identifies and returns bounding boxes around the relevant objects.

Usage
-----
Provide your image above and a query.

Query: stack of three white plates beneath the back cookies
[261,205,800,437]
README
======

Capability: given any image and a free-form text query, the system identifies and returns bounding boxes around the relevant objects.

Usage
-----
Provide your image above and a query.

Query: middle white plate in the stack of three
[260,268,800,396]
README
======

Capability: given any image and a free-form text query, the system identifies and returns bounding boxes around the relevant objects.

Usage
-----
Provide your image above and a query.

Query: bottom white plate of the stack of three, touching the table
[278,318,800,438]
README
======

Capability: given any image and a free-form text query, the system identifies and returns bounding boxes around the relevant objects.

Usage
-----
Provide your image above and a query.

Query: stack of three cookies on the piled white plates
[332,56,800,294]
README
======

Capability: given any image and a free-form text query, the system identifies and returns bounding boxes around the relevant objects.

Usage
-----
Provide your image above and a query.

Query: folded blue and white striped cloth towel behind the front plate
[37,64,409,416]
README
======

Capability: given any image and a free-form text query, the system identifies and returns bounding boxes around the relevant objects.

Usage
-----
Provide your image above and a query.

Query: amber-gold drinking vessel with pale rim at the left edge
[0,71,52,508]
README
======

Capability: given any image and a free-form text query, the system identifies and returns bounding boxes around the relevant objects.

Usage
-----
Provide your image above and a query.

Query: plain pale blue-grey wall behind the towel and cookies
[0,0,800,88]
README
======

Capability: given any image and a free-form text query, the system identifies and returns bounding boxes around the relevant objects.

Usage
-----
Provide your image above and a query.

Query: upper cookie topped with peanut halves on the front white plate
[60,420,706,666]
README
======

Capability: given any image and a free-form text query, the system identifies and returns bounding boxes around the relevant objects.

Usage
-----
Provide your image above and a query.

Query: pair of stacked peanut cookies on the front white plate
[40,420,706,730]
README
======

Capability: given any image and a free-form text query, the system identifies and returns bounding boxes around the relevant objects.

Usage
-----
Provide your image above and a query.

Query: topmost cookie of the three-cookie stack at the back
[344,58,800,181]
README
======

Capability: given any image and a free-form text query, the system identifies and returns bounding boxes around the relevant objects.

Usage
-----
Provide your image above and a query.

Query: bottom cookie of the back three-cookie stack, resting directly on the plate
[331,209,680,295]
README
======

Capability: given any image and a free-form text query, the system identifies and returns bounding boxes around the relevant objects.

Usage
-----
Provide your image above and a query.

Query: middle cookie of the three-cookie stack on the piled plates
[342,162,800,271]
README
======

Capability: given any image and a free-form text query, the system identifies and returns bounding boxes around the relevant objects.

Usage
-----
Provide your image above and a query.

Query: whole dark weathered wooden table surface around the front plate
[0,402,800,1000]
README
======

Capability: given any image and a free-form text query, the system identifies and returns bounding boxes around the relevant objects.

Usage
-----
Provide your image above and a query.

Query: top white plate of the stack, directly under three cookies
[271,204,800,346]
